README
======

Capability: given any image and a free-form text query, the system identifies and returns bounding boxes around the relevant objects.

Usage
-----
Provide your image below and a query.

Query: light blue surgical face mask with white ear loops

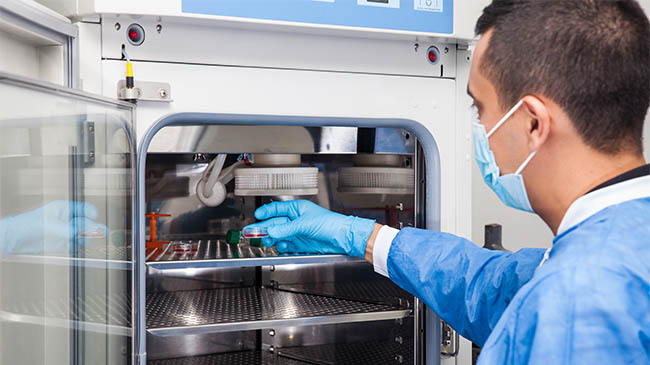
[473,100,536,213]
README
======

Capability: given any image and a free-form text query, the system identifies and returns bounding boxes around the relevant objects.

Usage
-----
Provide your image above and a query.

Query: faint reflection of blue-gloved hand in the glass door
[0,200,108,254]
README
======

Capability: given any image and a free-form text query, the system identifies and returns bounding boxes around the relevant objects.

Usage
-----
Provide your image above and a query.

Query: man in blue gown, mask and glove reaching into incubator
[246,0,650,364]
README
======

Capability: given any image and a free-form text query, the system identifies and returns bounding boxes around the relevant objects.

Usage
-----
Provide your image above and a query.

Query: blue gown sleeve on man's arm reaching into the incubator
[388,228,545,346]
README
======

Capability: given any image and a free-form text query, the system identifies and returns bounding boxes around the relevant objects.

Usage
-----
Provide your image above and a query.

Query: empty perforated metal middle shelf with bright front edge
[147,287,410,336]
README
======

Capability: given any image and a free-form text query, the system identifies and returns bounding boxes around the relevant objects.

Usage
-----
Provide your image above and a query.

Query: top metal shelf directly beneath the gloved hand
[147,240,358,270]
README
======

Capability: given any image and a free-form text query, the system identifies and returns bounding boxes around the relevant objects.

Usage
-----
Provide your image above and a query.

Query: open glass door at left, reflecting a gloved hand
[0,74,136,365]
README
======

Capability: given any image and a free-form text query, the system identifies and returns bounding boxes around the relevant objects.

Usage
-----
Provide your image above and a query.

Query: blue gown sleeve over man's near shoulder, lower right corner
[481,266,650,365]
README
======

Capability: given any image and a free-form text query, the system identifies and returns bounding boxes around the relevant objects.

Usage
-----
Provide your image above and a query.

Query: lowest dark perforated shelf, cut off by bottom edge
[147,351,309,365]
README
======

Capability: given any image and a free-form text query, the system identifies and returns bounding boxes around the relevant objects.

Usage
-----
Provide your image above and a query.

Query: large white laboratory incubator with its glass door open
[0,0,481,364]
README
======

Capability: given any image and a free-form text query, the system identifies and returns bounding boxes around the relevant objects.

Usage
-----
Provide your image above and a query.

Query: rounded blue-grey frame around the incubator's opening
[133,113,441,364]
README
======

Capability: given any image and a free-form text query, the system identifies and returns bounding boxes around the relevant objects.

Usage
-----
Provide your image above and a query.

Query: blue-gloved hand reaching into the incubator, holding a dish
[243,200,375,258]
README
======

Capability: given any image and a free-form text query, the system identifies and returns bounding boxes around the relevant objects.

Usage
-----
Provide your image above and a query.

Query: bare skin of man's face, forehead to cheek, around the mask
[467,31,528,174]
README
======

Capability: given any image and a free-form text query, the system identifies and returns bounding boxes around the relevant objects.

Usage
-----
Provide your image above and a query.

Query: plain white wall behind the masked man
[472,0,650,251]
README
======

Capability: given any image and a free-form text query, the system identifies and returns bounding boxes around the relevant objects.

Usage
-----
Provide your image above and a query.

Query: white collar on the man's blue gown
[557,176,650,236]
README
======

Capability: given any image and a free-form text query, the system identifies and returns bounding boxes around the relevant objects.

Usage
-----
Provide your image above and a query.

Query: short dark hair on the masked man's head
[476,0,650,154]
